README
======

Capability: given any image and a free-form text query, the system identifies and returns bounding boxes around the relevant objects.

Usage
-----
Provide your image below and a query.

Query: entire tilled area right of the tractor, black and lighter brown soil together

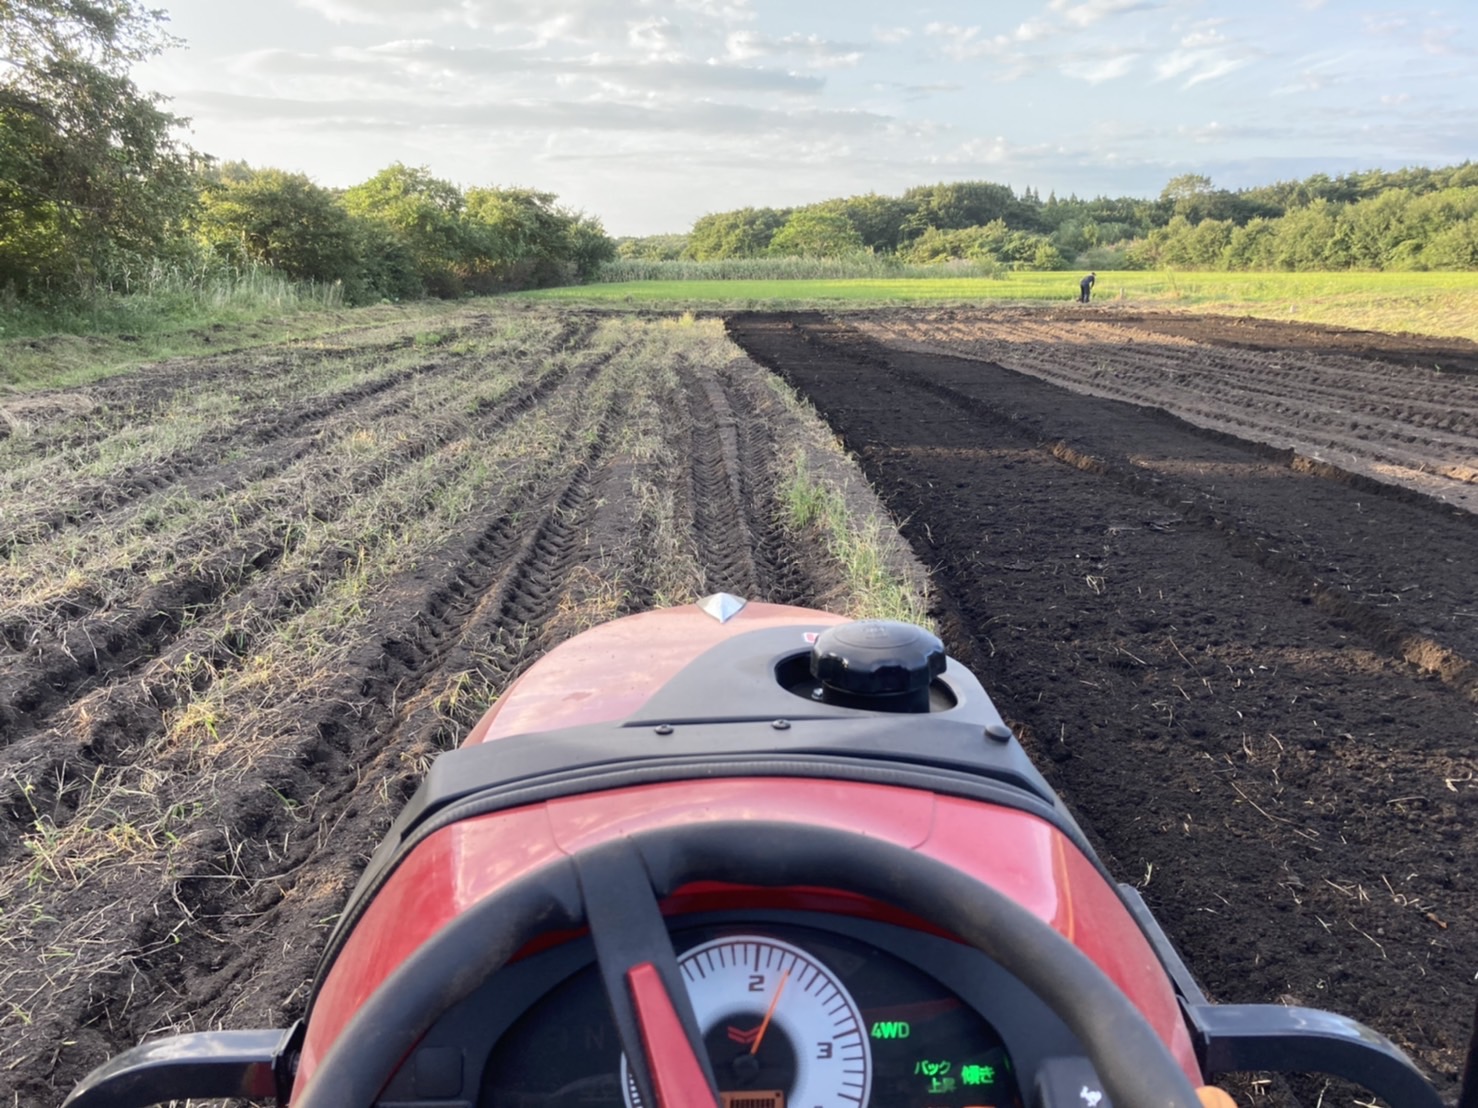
[729,309,1478,1104]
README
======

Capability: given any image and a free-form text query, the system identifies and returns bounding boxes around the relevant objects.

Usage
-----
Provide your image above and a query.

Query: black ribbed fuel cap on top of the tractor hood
[811,619,944,712]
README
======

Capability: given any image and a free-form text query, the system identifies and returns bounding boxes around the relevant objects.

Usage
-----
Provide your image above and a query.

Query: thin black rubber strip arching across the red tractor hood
[309,750,1117,1013]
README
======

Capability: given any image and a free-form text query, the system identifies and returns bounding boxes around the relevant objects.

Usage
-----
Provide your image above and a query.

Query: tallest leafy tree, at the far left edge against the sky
[0,0,195,294]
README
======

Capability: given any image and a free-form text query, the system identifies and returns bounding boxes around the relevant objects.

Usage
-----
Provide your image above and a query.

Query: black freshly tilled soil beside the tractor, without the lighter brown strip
[730,315,1478,1099]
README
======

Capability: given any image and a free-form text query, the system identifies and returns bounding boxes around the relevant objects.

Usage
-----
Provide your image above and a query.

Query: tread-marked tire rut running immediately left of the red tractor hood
[0,348,618,1105]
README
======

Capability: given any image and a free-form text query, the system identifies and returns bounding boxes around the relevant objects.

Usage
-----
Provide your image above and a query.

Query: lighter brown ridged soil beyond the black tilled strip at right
[854,307,1478,511]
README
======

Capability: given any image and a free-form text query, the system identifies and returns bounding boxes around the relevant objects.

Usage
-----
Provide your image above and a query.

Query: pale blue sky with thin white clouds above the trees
[134,0,1478,235]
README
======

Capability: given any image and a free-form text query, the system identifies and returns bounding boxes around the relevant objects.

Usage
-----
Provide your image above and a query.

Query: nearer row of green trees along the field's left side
[0,0,615,303]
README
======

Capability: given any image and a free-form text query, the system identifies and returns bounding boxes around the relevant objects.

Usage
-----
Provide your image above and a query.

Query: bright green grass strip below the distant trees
[520,270,1478,341]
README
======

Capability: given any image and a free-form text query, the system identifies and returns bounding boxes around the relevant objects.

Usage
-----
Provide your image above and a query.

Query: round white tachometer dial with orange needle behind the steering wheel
[621,935,872,1108]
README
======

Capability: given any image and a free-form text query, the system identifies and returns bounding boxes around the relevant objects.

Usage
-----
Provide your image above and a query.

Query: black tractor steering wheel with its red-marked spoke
[294,820,1200,1108]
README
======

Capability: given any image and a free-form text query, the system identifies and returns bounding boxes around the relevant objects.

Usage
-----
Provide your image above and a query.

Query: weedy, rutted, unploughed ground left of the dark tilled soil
[0,310,922,1105]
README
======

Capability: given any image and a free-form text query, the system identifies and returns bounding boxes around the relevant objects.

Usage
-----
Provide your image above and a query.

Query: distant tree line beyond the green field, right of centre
[616,163,1478,270]
